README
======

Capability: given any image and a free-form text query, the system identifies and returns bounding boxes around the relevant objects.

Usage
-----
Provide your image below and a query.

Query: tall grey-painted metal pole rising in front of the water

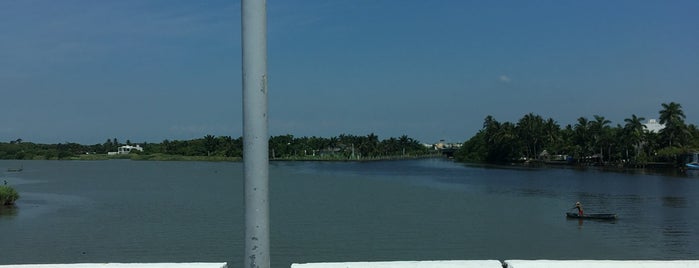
[241,0,270,268]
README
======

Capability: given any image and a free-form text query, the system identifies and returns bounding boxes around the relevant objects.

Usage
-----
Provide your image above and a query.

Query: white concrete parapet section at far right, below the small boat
[505,260,699,268]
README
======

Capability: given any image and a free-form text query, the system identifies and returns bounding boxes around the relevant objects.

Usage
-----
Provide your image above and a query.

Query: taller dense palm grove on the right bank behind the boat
[455,102,699,165]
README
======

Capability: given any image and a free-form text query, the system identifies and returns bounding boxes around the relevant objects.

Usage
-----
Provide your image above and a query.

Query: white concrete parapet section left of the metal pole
[0,262,226,268]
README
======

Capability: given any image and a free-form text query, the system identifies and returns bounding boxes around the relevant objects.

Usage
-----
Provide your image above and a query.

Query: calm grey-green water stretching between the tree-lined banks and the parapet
[0,159,699,267]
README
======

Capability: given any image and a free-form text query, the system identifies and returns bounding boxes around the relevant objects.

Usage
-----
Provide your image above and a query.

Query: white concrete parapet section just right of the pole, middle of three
[291,260,502,268]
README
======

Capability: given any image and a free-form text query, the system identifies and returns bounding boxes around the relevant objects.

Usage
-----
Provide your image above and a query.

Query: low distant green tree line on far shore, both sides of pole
[0,133,430,160]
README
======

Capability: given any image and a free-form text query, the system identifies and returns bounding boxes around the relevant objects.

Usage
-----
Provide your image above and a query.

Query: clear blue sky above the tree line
[0,0,699,144]
